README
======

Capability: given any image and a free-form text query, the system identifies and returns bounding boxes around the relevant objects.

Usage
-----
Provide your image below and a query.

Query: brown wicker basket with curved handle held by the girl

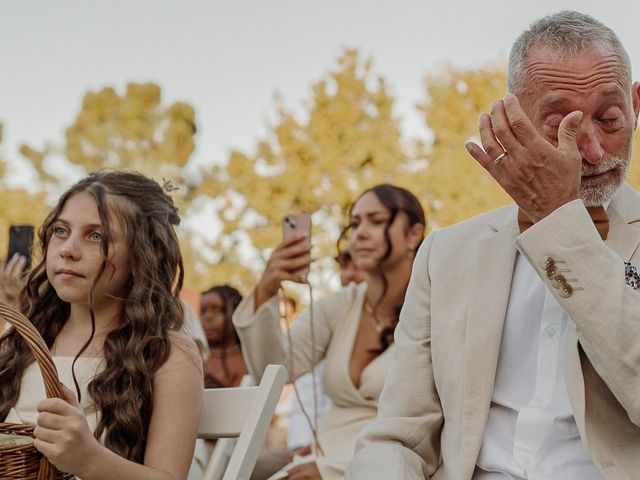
[0,300,75,480]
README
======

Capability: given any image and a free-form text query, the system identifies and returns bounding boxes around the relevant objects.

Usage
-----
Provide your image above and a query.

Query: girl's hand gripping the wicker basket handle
[34,386,103,477]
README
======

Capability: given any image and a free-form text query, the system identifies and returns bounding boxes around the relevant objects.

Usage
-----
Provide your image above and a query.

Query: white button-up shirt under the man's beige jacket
[473,252,602,480]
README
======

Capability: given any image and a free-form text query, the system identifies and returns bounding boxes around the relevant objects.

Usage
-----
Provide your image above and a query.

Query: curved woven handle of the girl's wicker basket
[0,299,63,398]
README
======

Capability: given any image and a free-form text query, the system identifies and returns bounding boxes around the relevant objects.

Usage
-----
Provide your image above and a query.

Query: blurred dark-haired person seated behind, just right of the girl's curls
[200,285,248,388]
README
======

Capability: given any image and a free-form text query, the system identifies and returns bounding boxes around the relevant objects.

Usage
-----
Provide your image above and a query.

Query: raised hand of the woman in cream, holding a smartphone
[254,235,311,310]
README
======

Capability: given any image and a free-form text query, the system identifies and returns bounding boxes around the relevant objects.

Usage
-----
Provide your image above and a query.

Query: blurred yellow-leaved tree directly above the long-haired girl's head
[20,83,196,198]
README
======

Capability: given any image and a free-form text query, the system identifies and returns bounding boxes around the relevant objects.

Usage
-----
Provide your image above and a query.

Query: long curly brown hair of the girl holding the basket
[0,171,183,463]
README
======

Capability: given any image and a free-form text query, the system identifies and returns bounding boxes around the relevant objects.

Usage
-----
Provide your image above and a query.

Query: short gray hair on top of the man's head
[507,10,632,95]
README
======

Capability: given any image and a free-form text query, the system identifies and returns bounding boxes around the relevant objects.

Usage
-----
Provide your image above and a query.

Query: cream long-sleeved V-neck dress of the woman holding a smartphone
[233,284,394,480]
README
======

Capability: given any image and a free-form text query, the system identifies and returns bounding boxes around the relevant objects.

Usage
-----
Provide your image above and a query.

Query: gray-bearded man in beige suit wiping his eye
[346,12,640,480]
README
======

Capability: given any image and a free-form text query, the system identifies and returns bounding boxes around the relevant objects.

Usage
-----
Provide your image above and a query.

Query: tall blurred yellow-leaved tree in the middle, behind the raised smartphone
[199,50,416,290]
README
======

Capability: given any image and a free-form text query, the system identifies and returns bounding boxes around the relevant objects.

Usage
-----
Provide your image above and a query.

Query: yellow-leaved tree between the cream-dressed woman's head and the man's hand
[418,65,510,228]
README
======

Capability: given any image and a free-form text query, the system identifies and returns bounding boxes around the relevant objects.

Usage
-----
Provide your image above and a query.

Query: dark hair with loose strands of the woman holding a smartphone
[336,183,426,353]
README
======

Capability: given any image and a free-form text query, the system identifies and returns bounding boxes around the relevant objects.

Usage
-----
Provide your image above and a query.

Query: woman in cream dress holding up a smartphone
[233,184,425,480]
